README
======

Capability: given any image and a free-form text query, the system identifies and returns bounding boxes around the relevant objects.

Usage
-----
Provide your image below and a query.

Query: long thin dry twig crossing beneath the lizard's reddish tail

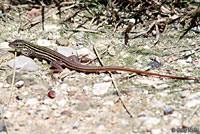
[93,45,133,118]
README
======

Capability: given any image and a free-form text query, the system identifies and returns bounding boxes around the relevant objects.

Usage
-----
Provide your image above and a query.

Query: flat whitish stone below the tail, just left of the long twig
[92,82,112,96]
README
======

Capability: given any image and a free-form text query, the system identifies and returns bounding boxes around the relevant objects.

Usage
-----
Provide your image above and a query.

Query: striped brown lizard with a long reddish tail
[9,40,199,81]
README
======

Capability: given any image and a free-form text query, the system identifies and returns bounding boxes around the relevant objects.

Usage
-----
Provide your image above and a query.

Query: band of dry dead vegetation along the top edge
[0,0,200,45]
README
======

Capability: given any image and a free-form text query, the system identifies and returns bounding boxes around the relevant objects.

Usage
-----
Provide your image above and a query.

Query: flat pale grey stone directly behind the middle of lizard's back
[57,46,77,57]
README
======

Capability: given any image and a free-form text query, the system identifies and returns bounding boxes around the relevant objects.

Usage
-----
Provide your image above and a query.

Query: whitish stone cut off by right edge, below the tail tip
[185,92,200,108]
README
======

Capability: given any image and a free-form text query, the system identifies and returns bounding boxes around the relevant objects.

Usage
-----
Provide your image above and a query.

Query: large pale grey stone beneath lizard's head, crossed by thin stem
[7,55,38,72]
